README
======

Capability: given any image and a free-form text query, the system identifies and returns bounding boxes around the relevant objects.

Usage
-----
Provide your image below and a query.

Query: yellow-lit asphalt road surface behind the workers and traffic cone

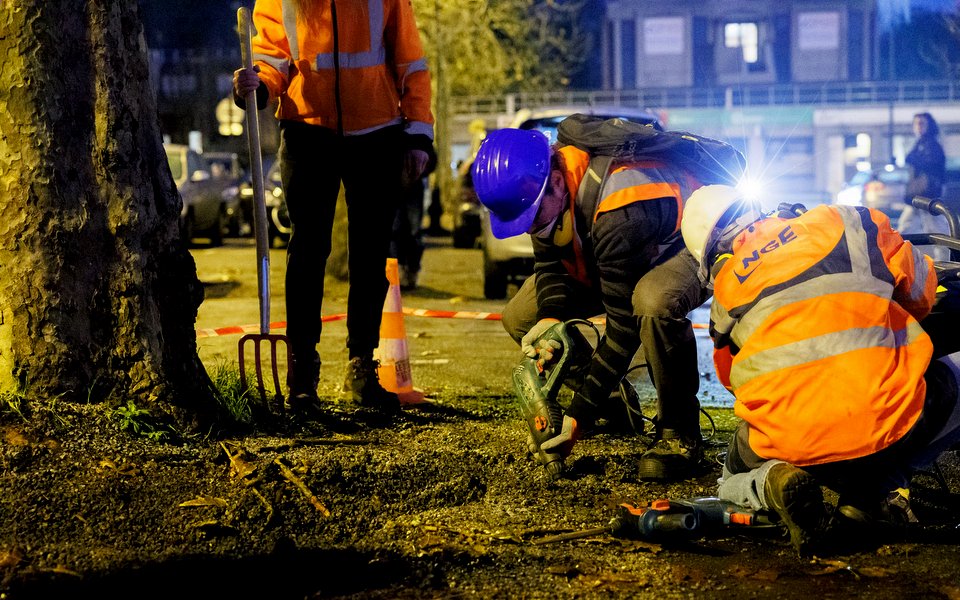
[191,238,732,406]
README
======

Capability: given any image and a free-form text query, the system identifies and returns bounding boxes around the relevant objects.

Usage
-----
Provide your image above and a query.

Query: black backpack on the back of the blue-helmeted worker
[557,113,747,185]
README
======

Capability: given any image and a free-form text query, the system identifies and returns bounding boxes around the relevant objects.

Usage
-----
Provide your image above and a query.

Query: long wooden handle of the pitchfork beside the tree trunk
[237,7,270,334]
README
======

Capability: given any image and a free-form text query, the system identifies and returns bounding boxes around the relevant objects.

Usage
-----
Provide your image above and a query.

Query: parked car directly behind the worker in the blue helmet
[476,106,660,299]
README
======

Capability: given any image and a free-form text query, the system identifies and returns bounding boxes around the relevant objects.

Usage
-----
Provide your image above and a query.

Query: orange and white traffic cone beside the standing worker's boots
[374,258,424,404]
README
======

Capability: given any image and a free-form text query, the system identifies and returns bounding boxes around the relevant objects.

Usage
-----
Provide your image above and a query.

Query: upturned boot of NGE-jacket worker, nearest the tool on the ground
[763,463,830,556]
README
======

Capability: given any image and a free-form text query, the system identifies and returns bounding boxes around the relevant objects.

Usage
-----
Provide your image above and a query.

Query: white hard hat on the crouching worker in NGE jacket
[680,184,763,281]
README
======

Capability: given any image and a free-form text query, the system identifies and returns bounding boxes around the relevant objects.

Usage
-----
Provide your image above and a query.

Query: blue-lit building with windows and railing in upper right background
[453,0,960,200]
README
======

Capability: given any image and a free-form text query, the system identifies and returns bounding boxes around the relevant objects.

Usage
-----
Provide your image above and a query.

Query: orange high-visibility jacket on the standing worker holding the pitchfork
[253,0,433,140]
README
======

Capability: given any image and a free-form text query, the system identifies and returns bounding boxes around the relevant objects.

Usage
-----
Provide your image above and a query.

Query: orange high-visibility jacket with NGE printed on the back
[710,206,937,466]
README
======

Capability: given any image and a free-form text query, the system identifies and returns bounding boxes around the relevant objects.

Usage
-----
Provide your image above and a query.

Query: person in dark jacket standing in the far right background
[897,112,947,260]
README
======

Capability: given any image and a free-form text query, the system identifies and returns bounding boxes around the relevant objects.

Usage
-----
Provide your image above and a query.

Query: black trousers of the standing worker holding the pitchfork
[279,121,405,357]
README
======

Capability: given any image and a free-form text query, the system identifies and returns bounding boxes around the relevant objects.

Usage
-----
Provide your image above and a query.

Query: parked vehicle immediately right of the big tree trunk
[163,144,237,246]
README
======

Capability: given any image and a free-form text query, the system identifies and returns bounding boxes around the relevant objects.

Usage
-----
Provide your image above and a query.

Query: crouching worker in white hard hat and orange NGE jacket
[681,186,960,554]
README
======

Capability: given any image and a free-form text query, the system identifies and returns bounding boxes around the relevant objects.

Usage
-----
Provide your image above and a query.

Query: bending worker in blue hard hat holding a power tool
[473,128,709,480]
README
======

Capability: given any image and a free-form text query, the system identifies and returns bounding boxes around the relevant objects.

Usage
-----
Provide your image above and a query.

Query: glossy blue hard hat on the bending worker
[473,129,550,238]
